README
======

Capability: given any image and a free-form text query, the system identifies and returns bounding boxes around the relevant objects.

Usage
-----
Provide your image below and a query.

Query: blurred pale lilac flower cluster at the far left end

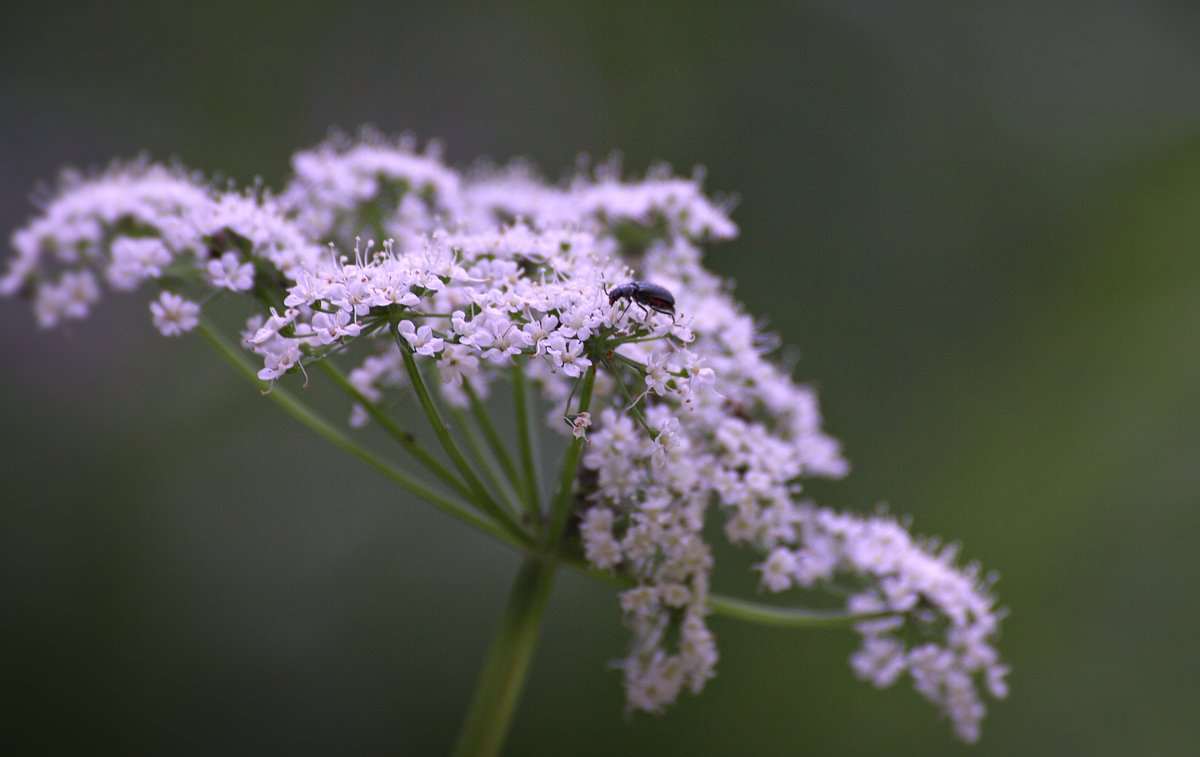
[0,162,322,336]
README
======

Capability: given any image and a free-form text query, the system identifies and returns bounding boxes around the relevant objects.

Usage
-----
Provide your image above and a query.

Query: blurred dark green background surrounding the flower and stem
[0,0,1200,755]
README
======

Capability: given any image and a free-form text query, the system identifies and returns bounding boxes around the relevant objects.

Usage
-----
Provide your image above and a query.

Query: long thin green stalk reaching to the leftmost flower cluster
[198,320,530,551]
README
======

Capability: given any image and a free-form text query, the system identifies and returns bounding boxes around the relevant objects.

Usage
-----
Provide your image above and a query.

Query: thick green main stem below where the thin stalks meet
[454,554,556,757]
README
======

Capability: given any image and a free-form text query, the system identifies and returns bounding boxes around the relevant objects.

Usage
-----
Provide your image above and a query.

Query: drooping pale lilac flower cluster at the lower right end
[777,506,1008,741]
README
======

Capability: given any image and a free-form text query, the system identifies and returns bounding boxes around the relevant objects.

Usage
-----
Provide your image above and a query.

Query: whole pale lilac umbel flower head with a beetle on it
[0,134,1008,741]
